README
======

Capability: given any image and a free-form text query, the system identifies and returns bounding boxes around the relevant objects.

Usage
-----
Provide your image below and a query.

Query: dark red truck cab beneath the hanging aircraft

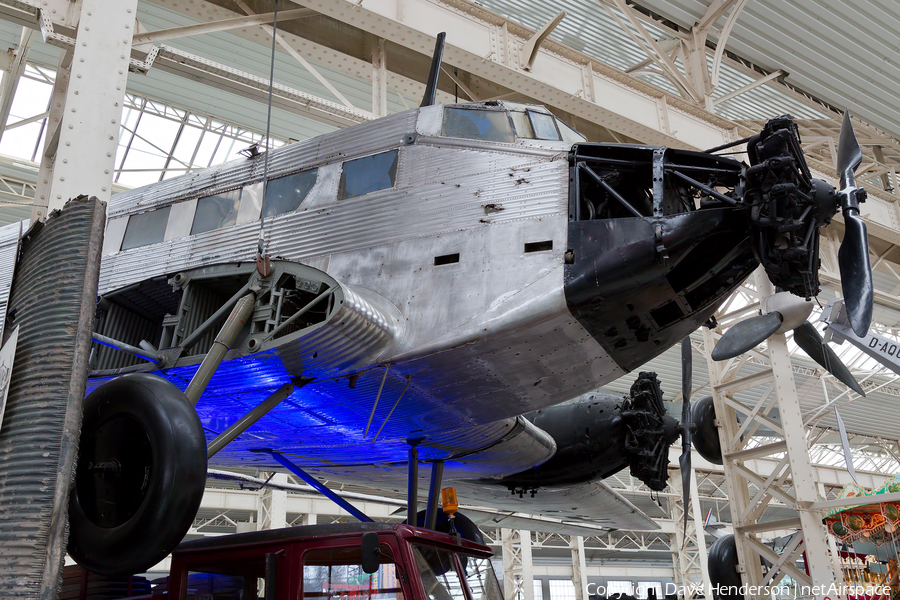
[154,523,503,600]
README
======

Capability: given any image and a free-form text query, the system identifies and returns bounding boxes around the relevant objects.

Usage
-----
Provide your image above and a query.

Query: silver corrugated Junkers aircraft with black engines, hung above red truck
[29,35,872,573]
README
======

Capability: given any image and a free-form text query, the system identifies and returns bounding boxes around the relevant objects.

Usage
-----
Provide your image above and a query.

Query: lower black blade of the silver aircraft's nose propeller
[838,210,875,337]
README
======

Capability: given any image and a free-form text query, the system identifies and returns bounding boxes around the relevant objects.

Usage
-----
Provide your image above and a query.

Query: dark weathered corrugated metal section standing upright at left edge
[0,198,105,598]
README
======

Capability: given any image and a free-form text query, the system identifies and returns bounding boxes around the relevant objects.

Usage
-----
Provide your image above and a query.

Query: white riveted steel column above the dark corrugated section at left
[31,0,137,222]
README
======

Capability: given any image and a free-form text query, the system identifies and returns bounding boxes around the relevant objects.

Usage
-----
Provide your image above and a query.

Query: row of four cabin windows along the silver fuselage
[120,150,397,250]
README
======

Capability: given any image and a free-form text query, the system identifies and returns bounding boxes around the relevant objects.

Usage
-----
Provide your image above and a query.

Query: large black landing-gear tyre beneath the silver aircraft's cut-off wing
[68,373,206,576]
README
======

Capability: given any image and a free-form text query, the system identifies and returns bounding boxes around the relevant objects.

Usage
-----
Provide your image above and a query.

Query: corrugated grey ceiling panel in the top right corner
[640,0,900,136]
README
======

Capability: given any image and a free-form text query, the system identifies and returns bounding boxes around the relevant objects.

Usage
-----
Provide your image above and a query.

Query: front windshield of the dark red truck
[413,544,503,600]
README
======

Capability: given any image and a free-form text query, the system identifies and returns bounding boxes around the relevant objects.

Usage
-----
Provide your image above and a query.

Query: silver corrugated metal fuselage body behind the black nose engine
[99,107,624,429]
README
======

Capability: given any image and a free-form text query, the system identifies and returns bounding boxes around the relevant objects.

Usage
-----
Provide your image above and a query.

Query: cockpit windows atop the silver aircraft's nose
[441,102,587,144]
